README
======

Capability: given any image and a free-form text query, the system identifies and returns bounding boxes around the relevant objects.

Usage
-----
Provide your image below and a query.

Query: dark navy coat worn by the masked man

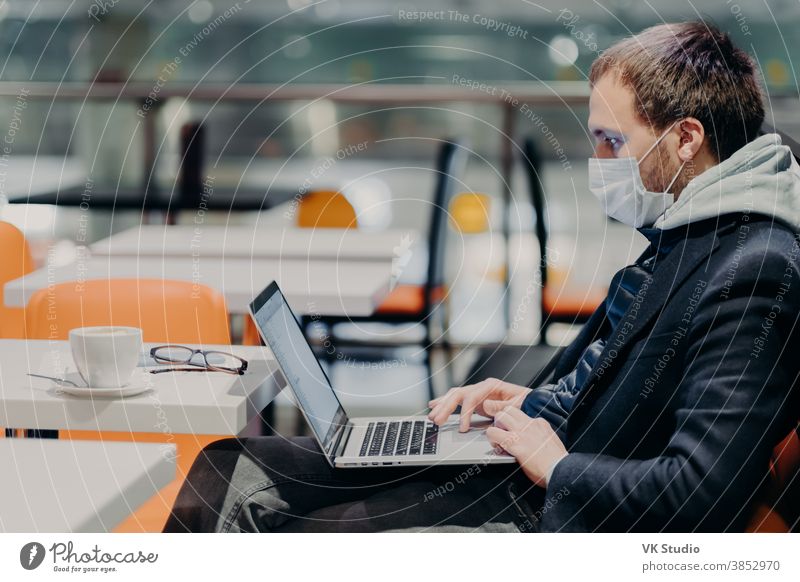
[526,214,800,532]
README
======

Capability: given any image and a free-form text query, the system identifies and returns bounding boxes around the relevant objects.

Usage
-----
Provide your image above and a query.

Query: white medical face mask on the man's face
[589,121,686,228]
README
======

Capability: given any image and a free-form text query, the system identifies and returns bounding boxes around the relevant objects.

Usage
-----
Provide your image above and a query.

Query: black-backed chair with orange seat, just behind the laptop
[302,139,469,396]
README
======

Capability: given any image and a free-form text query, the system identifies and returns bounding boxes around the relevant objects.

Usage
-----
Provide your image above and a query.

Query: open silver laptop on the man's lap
[249,282,515,468]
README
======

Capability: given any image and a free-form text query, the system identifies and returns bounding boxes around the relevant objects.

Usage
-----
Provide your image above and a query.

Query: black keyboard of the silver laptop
[359,420,439,457]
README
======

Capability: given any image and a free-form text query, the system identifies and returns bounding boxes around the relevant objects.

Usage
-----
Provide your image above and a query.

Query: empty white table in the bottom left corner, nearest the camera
[0,439,175,533]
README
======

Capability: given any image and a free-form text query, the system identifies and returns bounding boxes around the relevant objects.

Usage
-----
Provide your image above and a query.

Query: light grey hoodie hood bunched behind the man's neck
[653,133,800,233]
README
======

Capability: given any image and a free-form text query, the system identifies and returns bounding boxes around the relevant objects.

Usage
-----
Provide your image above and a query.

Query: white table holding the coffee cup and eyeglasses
[0,340,285,436]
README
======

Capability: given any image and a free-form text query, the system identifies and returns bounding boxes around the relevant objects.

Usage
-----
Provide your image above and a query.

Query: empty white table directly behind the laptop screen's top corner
[4,256,393,316]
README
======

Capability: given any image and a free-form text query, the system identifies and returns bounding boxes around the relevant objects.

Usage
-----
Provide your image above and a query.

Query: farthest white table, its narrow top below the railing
[90,224,419,264]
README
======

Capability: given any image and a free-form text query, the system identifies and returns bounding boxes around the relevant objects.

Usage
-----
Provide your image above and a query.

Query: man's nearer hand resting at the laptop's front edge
[486,406,568,489]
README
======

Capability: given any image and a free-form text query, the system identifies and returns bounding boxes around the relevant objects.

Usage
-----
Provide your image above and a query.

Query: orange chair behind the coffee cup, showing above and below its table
[26,279,230,532]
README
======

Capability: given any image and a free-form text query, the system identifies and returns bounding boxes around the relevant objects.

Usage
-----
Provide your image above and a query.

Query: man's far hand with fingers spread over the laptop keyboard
[428,378,531,432]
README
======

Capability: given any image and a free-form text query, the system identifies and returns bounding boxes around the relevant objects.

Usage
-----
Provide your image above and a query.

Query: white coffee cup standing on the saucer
[69,326,142,388]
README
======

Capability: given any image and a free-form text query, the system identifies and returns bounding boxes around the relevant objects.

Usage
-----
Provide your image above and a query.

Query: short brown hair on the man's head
[589,22,764,161]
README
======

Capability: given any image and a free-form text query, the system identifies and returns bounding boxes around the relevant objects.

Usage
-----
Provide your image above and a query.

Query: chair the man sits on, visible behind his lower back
[747,426,800,532]
